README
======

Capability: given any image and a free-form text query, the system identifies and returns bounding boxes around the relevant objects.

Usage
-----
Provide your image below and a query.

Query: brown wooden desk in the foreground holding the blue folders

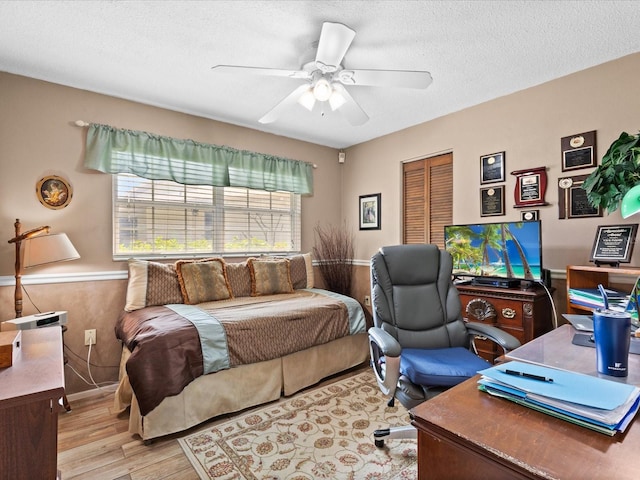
[411,325,640,480]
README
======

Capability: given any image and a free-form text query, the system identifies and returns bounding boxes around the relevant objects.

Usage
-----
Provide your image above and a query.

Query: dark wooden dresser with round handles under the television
[457,285,553,363]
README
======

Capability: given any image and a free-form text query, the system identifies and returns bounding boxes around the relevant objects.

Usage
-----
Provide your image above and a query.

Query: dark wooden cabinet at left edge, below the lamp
[0,328,64,480]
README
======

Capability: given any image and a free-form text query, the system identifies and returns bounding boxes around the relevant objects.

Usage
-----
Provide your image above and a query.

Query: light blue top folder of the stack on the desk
[478,361,640,410]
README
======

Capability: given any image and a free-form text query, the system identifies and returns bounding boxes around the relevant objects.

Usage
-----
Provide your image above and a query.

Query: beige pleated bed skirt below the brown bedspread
[114,333,369,440]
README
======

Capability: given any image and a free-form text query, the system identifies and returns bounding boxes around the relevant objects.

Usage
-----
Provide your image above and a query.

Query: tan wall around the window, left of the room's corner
[0,73,342,393]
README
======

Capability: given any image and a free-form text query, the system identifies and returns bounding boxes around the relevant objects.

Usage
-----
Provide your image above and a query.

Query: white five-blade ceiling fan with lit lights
[212,22,433,126]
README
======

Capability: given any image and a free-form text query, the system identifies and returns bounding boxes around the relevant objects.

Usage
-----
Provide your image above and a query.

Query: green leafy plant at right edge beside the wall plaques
[582,132,640,213]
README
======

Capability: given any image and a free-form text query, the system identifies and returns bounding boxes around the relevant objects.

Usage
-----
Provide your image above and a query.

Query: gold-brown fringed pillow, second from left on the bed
[176,258,232,305]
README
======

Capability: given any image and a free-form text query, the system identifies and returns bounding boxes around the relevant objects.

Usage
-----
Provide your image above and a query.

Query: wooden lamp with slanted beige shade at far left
[9,219,80,318]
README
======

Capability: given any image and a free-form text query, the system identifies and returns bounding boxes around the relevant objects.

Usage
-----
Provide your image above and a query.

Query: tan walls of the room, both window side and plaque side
[0,54,640,392]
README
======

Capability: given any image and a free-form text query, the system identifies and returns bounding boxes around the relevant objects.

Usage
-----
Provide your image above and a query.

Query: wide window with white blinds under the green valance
[113,173,301,259]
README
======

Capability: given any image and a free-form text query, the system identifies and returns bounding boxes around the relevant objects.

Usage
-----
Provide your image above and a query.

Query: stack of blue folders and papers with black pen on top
[478,361,640,436]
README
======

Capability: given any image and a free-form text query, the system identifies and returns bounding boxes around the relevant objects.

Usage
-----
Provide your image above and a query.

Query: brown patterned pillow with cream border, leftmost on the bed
[124,258,183,312]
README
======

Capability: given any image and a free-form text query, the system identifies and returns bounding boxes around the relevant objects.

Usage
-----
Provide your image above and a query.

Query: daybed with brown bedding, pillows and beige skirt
[115,254,369,441]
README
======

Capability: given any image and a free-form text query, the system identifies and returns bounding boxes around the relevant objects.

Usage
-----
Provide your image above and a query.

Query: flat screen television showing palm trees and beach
[444,220,544,282]
